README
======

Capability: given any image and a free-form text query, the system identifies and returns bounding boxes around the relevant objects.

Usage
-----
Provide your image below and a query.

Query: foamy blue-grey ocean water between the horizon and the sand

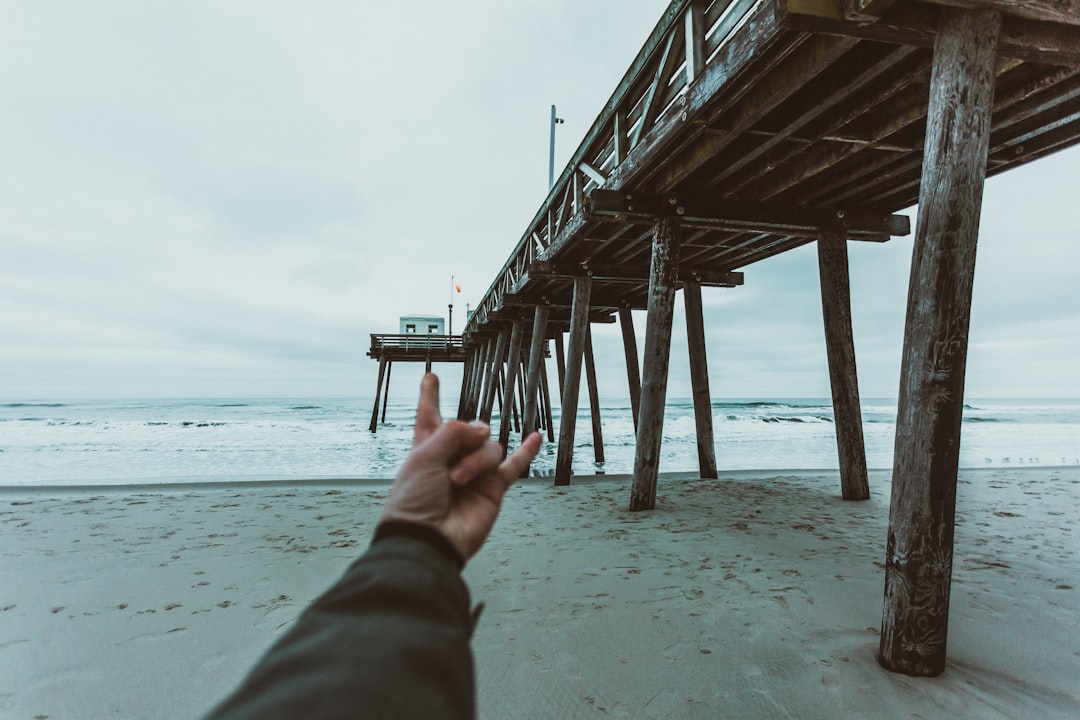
[0,398,1080,486]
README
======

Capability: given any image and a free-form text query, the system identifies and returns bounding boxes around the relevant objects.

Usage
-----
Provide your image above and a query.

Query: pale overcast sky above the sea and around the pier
[0,0,1080,400]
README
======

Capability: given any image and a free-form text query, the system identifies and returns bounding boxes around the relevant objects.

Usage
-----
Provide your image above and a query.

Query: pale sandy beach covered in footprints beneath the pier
[0,467,1080,720]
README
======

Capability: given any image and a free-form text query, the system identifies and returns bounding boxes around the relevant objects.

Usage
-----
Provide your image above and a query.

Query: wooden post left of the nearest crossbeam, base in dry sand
[630,216,681,511]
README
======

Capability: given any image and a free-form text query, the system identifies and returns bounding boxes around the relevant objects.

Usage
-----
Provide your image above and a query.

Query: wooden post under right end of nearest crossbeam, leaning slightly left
[818,230,870,500]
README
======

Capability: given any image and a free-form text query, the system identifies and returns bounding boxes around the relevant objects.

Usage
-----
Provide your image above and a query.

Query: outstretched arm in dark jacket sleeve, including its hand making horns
[210,375,540,720]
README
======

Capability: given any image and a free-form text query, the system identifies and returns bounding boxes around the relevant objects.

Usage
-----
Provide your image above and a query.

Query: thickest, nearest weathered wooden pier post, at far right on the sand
[878,8,1001,676]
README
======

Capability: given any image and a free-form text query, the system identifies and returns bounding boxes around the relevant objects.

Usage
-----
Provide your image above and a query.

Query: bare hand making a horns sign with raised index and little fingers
[379,372,541,560]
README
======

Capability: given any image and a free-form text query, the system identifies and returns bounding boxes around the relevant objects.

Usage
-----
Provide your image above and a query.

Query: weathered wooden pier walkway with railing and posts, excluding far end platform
[375,0,1080,675]
